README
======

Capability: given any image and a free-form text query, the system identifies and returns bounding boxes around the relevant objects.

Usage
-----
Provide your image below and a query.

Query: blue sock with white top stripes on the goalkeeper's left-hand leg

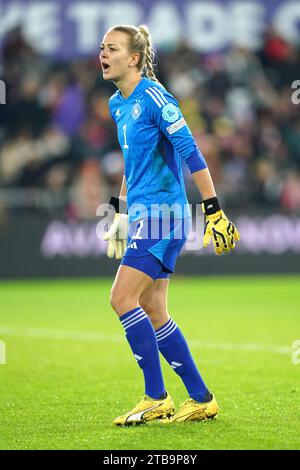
[120,307,166,399]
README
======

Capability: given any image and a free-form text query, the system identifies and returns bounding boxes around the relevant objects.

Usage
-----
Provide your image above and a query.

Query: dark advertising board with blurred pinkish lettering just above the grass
[0,214,300,279]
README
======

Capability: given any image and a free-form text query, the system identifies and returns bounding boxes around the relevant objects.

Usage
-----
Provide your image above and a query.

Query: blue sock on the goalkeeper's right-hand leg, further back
[155,318,210,402]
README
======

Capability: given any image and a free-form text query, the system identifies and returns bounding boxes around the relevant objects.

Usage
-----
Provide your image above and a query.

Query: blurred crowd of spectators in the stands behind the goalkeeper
[0,28,300,219]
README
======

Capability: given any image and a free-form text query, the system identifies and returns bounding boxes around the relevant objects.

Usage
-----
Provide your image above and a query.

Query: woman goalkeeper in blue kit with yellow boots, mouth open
[100,25,239,426]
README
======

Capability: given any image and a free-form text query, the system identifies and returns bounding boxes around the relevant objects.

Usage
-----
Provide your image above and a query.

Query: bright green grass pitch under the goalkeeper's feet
[0,276,300,450]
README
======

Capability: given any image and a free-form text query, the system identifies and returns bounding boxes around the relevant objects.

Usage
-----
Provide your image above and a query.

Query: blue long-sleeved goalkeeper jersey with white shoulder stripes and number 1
[109,78,206,221]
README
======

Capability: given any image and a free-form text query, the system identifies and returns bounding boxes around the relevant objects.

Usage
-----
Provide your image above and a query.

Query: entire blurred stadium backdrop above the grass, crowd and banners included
[0,0,300,278]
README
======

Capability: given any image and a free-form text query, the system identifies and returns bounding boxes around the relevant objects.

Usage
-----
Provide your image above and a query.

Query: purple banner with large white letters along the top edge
[0,0,300,58]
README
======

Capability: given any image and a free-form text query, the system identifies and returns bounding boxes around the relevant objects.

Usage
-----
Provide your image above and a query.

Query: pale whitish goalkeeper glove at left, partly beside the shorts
[103,213,128,259]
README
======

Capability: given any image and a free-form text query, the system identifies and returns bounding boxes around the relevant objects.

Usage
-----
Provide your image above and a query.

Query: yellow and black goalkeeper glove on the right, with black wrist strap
[202,197,240,255]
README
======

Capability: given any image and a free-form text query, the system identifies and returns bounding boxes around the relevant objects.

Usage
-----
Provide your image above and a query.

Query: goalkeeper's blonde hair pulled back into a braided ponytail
[109,25,158,82]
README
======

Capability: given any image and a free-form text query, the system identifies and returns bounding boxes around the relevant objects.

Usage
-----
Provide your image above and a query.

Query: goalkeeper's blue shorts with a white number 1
[121,218,191,280]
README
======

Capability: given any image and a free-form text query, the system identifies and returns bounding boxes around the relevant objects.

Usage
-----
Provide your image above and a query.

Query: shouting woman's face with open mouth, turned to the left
[99,31,133,82]
